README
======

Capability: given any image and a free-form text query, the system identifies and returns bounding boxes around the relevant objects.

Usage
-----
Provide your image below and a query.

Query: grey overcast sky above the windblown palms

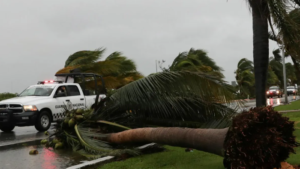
[0,0,289,93]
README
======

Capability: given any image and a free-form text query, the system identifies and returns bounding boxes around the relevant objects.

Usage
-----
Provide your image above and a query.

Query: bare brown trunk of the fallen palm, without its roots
[104,127,228,156]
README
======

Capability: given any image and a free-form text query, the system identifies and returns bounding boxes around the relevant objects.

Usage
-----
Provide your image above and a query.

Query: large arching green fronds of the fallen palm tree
[97,72,235,126]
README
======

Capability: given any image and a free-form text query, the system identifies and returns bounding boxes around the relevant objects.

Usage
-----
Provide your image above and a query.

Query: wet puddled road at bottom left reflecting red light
[0,145,87,169]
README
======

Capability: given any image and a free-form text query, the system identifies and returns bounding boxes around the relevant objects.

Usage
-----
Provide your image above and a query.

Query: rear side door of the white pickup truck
[67,85,86,109]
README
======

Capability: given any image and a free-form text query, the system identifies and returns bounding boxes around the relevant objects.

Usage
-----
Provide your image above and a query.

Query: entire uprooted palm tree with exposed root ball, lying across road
[44,72,298,168]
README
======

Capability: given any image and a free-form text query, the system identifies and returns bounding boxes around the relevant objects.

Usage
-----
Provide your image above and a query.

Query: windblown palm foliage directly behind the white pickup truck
[56,49,142,89]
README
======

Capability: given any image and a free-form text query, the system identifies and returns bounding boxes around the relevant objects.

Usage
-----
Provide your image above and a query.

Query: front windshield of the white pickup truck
[19,86,54,97]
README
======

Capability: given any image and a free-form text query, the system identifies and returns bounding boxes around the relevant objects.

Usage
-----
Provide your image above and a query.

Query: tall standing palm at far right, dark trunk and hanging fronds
[247,0,300,107]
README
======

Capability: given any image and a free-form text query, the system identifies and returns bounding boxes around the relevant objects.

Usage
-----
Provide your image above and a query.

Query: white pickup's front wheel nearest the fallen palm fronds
[35,110,51,131]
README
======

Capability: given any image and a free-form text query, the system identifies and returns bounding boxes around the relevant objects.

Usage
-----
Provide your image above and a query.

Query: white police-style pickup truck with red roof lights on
[0,73,106,132]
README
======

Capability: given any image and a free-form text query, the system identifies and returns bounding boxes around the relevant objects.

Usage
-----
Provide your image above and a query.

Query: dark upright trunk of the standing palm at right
[249,0,269,107]
